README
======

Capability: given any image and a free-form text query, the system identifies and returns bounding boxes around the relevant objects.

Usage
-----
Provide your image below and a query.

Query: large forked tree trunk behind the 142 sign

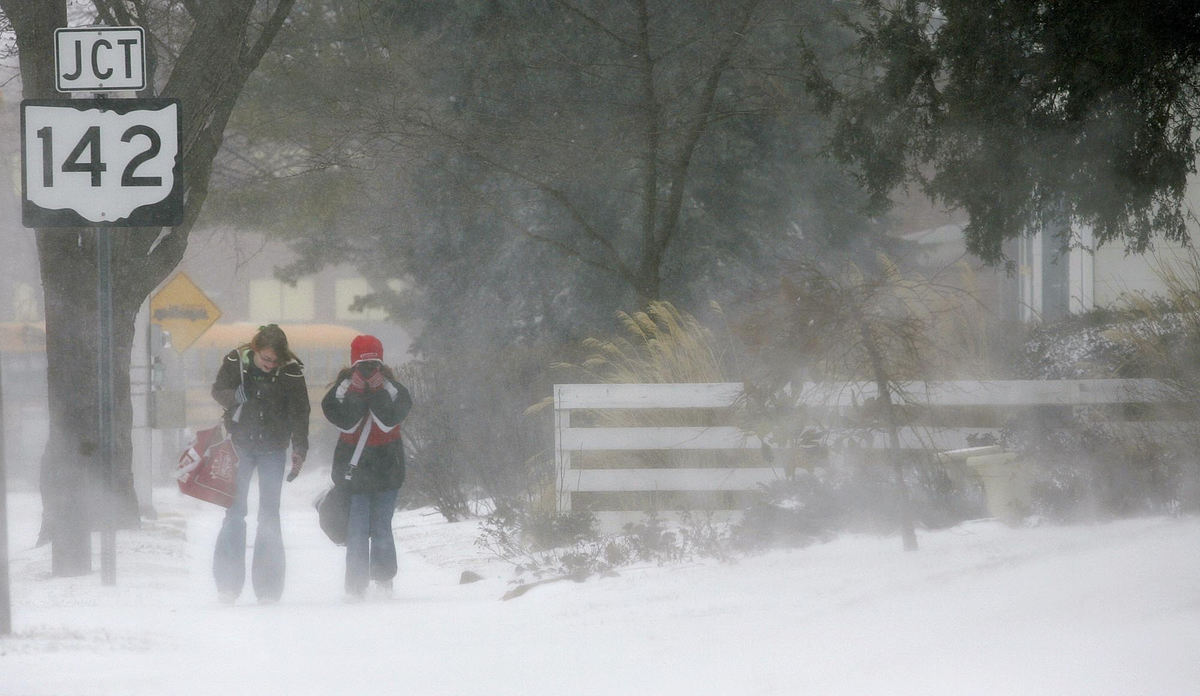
[0,0,295,575]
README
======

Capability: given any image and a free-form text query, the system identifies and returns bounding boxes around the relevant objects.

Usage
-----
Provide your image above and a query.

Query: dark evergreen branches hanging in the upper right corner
[830,0,1200,262]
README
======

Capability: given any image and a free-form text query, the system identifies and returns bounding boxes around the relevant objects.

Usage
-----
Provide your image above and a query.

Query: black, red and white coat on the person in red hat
[320,371,413,493]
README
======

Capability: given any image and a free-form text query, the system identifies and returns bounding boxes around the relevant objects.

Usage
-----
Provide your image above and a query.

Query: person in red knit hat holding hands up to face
[320,336,413,600]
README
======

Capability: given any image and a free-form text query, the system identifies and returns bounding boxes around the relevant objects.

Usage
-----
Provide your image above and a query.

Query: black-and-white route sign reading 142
[20,98,184,227]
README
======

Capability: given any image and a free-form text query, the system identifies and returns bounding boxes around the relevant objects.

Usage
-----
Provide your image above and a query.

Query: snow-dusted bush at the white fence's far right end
[1003,285,1200,520]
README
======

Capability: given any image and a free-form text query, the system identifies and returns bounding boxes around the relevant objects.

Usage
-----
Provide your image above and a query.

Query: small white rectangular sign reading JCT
[54,26,146,92]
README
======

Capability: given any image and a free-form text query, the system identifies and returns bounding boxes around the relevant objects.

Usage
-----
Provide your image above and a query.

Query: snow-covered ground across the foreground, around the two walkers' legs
[0,472,1200,696]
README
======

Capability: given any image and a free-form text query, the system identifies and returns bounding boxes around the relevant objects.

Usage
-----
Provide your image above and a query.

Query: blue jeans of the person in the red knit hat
[346,488,398,595]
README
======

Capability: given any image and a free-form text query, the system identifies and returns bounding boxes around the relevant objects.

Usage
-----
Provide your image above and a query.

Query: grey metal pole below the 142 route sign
[96,227,116,586]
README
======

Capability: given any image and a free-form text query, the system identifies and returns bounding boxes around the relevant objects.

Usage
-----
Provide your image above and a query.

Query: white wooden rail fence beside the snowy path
[554,379,1171,521]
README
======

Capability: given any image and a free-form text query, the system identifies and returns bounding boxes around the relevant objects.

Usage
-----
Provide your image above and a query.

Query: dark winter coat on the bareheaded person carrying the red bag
[212,348,310,456]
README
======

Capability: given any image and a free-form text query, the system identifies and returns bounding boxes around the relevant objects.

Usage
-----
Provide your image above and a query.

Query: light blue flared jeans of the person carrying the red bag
[212,449,287,601]
